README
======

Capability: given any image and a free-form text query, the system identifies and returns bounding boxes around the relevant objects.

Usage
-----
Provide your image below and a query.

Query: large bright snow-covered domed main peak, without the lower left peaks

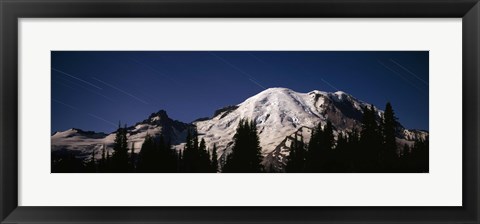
[194,88,428,170]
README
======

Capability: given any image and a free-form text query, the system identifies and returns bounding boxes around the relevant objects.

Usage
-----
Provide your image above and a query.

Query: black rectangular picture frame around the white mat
[0,0,480,224]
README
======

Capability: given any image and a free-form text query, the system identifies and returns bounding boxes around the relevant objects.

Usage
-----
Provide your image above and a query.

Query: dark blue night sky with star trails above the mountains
[51,51,429,133]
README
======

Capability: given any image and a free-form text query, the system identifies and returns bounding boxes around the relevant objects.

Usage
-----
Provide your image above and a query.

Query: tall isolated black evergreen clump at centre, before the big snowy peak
[222,119,263,173]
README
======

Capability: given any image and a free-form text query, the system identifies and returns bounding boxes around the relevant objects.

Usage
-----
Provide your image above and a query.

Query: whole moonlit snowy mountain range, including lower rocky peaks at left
[52,88,428,171]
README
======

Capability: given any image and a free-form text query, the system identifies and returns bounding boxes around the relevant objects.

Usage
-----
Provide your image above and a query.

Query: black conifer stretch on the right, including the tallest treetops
[285,103,429,173]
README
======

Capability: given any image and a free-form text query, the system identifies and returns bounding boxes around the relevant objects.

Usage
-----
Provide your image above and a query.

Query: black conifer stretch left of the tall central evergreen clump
[52,121,231,173]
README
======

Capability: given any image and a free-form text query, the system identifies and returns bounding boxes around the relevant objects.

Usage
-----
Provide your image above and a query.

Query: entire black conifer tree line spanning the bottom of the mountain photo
[52,103,429,173]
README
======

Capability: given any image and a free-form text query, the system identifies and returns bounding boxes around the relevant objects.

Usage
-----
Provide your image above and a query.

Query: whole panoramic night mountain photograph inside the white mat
[51,51,429,173]
